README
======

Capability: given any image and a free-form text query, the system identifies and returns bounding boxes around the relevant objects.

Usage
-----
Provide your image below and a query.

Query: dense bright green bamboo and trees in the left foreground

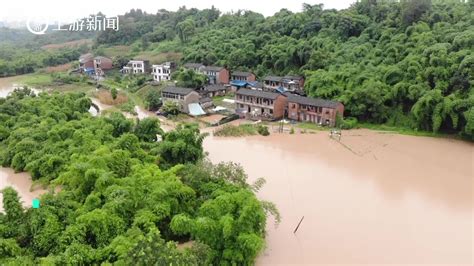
[0,89,278,265]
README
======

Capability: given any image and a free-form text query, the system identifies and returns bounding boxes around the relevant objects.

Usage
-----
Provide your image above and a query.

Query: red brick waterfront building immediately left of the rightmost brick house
[235,88,287,120]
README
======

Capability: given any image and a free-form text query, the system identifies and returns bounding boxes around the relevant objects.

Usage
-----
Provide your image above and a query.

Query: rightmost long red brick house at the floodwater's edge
[287,93,344,127]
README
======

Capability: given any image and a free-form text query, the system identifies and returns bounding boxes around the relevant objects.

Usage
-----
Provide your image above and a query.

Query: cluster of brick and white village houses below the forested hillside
[79,54,344,126]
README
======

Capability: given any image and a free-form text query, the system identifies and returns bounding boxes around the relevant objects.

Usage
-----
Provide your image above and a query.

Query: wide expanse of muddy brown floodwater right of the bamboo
[204,130,474,265]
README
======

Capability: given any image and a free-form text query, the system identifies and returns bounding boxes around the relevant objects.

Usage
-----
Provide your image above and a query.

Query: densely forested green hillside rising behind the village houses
[96,0,474,138]
